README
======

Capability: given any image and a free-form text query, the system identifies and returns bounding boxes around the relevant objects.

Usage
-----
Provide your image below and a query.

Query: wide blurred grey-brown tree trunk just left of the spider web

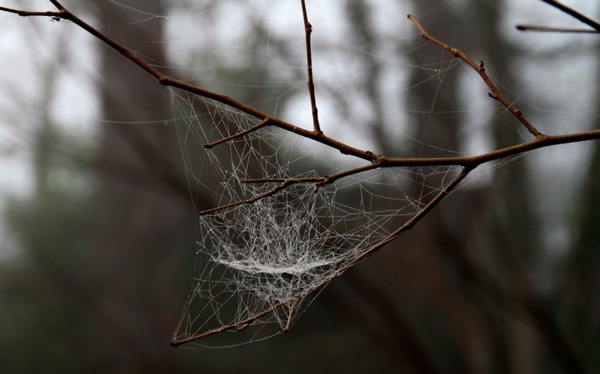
[95,0,190,371]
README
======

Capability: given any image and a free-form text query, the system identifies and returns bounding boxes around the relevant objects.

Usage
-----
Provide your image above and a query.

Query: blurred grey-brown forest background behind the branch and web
[0,0,600,373]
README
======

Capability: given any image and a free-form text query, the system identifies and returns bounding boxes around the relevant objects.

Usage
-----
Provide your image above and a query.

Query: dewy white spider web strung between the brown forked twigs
[170,89,461,346]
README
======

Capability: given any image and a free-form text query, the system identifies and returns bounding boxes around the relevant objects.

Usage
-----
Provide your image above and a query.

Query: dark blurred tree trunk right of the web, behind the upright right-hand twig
[408,0,494,373]
